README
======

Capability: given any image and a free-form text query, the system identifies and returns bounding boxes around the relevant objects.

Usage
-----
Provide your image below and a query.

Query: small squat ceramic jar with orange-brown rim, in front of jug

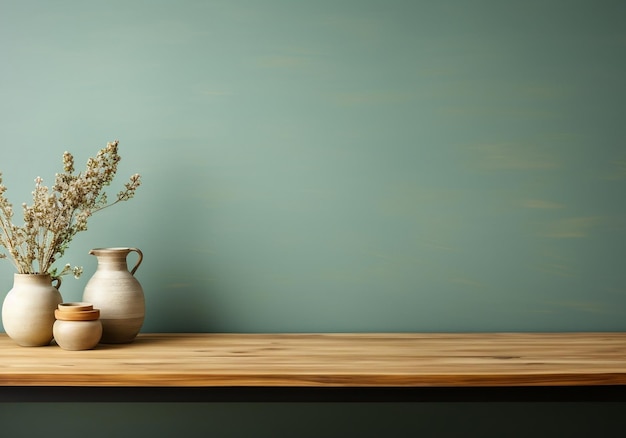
[52,303,102,350]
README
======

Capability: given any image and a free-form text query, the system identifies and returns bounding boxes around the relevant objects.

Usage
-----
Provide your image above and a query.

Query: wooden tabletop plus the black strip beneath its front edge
[0,333,626,401]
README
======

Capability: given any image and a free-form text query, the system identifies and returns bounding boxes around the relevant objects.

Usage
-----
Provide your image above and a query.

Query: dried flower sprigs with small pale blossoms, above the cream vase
[0,141,141,278]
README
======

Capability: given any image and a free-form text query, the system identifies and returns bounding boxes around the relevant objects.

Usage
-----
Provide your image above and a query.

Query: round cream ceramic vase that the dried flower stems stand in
[2,274,63,347]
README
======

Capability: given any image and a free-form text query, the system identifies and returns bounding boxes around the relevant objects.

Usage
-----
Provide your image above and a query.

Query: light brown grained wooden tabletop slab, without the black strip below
[0,333,626,387]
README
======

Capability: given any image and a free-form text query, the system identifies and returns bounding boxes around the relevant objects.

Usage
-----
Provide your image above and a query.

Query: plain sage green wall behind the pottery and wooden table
[0,0,626,332]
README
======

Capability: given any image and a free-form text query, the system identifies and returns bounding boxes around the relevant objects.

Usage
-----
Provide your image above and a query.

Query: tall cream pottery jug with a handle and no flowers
[83,248,146,344]
